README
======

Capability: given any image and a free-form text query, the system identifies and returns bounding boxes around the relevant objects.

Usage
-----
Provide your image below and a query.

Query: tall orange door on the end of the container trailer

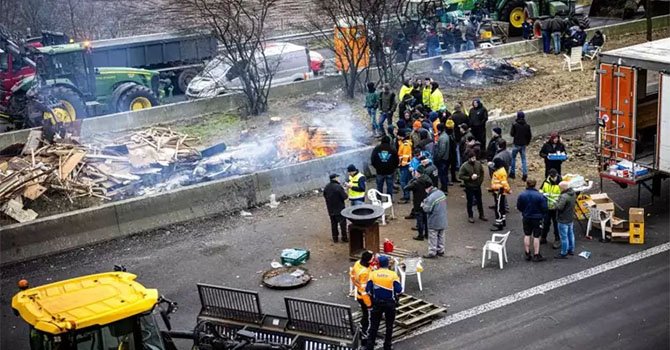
[598,64,637,161]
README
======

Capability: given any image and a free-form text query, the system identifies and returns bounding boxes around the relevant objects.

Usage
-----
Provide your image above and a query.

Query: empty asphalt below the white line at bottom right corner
[395,252,670,350]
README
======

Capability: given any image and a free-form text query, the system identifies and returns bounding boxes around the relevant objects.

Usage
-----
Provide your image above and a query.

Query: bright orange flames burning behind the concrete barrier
[277,124,337,162]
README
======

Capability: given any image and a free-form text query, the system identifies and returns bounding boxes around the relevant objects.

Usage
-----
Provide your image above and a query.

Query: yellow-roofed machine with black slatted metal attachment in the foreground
[12,267,360,350]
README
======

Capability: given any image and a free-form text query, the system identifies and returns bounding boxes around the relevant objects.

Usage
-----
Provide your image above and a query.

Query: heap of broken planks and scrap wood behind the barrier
[0,128,200,222]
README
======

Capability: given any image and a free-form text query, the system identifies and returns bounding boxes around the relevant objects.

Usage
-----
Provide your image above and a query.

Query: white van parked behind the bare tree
[186,43,325,99]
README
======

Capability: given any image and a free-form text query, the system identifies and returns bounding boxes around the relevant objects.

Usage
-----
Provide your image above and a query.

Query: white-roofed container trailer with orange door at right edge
[596,38,670,207]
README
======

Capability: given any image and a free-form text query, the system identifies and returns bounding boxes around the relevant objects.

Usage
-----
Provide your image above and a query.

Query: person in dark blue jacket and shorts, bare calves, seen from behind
[516,179,548,262]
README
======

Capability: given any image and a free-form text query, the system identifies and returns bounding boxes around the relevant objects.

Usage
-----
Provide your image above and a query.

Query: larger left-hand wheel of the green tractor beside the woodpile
[42,86,88,125]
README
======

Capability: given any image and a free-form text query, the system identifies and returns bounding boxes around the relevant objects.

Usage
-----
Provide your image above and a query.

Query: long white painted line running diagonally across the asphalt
[398,242,670,341]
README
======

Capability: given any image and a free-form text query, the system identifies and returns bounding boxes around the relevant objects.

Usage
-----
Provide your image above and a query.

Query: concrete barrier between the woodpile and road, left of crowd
[0,147,372,265]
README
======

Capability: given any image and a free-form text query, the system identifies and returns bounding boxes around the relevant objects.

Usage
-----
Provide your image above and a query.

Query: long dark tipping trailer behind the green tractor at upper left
[91,33,218,92]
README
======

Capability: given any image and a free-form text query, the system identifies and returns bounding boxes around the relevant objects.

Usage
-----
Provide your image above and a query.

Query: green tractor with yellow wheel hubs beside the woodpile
[9,42,164,126]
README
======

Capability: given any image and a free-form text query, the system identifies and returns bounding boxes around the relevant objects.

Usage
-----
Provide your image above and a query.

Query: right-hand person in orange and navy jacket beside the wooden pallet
[365,255,402,350]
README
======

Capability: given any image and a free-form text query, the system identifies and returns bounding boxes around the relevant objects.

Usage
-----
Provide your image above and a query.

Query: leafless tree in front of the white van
[163,0,279,115]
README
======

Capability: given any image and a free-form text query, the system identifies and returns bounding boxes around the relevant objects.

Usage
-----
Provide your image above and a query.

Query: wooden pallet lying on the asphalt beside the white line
[352,294,447,339]
